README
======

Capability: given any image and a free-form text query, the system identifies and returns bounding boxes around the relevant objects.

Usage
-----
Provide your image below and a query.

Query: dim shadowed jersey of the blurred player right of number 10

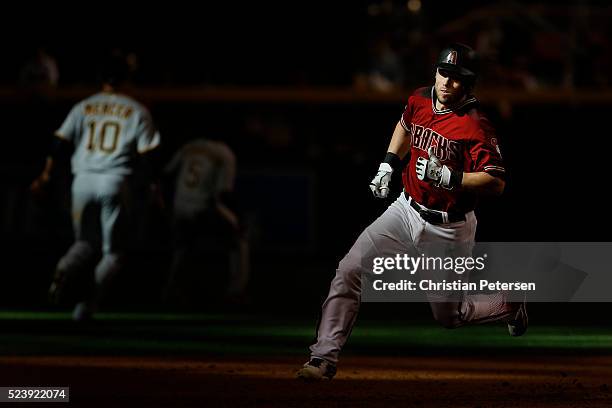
[166,139,236,213]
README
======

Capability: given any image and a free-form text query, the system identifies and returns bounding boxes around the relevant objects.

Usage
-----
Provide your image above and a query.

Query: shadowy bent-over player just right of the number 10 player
[164,138,249,301]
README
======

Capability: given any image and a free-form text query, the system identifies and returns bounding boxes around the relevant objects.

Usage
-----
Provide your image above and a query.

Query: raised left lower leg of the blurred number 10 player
[49,240,96,304]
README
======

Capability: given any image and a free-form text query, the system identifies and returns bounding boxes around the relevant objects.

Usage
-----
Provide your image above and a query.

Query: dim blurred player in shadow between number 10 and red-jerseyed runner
[163,138,249,306]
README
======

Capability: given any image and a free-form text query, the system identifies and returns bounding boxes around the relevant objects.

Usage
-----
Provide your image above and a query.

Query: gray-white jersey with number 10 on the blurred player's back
[56,92,160,175]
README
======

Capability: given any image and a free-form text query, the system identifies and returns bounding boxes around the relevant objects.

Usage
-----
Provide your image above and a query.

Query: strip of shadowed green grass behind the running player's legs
[0,311,612,355]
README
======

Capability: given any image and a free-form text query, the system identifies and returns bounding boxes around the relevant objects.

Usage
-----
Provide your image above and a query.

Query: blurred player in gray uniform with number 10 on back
[31,58,160,320]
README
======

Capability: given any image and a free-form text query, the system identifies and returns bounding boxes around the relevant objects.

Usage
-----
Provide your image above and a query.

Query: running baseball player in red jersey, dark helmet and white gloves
[297,44,527,380]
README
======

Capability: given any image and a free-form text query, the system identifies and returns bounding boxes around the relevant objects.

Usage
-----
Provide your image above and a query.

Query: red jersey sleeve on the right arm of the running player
[469,116,506,178]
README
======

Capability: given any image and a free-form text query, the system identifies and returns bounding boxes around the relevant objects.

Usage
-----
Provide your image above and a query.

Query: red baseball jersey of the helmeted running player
[401,87,505,212]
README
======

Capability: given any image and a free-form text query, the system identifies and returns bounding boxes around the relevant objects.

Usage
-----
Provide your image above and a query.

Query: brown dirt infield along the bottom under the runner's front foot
[0,356,612,408]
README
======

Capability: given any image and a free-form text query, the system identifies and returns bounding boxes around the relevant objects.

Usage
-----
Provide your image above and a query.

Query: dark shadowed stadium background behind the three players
[0,1,612,320]
